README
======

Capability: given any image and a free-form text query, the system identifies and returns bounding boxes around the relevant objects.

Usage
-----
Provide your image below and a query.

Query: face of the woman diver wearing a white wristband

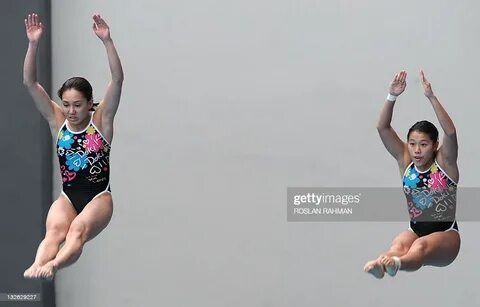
[408,131,438,169]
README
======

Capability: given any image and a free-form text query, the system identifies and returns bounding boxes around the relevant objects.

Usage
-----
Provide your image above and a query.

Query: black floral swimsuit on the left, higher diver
[56,114,110,213]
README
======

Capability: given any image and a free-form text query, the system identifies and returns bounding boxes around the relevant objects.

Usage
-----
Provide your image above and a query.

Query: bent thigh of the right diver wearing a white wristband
[414,230,460,266]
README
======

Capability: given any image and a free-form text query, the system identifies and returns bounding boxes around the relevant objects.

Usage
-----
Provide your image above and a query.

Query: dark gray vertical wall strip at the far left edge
[0,0,55,306]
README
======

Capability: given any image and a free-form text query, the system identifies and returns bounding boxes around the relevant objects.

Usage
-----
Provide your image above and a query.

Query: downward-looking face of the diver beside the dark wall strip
[62,89,93,125]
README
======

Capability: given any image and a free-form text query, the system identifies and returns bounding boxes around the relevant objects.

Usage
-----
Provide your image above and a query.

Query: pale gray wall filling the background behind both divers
[52,0,480,307]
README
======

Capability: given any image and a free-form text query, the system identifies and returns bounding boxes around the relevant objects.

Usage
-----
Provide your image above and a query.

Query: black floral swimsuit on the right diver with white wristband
[403,161,457,235]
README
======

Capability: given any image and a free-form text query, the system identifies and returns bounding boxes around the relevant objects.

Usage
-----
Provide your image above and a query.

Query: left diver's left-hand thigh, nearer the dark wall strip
[46,195,77,232]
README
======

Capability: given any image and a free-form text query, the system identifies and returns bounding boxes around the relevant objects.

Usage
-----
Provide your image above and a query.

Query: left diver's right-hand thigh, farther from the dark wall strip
[72,192,113,242]
